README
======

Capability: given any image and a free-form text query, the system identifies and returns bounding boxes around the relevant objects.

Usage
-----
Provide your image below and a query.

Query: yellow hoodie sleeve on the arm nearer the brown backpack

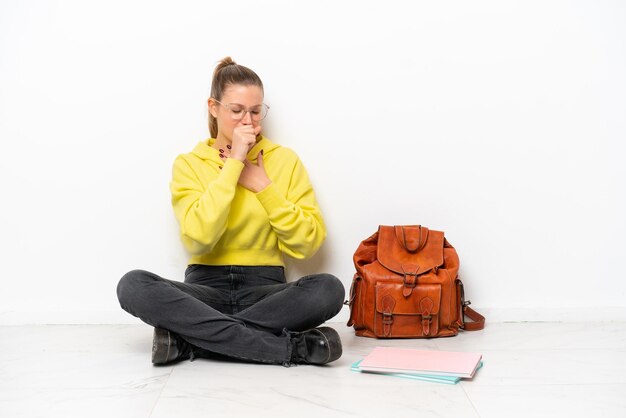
[257,155,326,259]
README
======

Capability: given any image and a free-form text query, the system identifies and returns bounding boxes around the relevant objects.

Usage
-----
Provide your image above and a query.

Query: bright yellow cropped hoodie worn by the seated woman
[170,137,326,266]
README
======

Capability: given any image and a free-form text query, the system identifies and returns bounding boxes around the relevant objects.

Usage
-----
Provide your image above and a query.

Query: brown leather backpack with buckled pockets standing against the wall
[347,225,485,338]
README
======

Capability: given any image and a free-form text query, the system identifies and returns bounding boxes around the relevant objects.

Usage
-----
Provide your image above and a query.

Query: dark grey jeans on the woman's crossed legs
[117,264,345,364]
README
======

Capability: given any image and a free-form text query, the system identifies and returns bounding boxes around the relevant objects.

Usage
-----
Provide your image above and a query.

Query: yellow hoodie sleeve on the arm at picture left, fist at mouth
[170,156,244,254]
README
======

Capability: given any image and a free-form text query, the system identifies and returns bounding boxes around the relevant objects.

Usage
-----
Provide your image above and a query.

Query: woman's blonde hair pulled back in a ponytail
[209,57,263,138]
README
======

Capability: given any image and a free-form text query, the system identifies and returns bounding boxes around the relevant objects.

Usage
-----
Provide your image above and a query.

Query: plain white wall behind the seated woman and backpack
[0,0,626,324]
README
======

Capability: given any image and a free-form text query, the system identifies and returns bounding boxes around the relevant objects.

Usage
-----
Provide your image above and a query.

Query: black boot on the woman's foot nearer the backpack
[291,327,342,364]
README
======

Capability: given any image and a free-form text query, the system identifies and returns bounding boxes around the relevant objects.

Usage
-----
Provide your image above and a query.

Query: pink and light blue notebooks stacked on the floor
[351,347,483,385]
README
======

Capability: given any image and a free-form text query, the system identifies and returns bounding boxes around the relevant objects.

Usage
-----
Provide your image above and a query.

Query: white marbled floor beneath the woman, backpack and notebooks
[0,322,626,418]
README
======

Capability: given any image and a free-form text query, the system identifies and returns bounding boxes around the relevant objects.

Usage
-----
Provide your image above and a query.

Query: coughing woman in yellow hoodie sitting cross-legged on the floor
[117,57,345,365]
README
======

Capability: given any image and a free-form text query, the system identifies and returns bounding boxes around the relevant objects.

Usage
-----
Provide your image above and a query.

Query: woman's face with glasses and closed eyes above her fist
[209,84,263,142]
